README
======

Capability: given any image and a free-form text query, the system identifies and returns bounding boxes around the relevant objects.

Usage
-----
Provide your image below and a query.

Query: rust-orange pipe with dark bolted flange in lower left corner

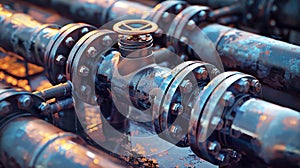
[0,89,124,167]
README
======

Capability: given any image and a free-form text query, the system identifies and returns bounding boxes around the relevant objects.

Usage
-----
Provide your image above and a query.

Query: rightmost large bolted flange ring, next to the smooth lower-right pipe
[189,72,261,165]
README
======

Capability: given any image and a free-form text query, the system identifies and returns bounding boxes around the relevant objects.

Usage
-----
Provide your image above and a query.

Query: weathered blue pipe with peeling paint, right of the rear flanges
[202,24,300,93]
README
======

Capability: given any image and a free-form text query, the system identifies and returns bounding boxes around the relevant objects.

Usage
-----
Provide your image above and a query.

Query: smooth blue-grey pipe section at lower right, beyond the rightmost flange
[224,98,300,168]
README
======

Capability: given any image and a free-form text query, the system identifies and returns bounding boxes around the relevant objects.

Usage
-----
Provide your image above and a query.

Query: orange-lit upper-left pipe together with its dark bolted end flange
[0,6,96,84]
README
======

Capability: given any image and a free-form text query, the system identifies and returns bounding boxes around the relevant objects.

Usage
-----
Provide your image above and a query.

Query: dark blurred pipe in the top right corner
[238,0,300,33]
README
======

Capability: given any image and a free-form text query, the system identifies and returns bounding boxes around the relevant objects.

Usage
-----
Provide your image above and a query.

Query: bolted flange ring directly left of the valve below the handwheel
[69,30,118,105]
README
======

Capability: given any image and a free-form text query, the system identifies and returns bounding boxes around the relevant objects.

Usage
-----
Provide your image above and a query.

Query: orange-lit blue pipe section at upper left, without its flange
[0,6,59,65]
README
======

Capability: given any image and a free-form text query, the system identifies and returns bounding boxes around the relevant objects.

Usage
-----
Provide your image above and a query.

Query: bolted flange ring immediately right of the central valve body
[160,61,219,146]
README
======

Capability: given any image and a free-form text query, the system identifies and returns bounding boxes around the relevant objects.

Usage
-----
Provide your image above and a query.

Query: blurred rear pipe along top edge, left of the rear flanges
[23,0,152,26]
